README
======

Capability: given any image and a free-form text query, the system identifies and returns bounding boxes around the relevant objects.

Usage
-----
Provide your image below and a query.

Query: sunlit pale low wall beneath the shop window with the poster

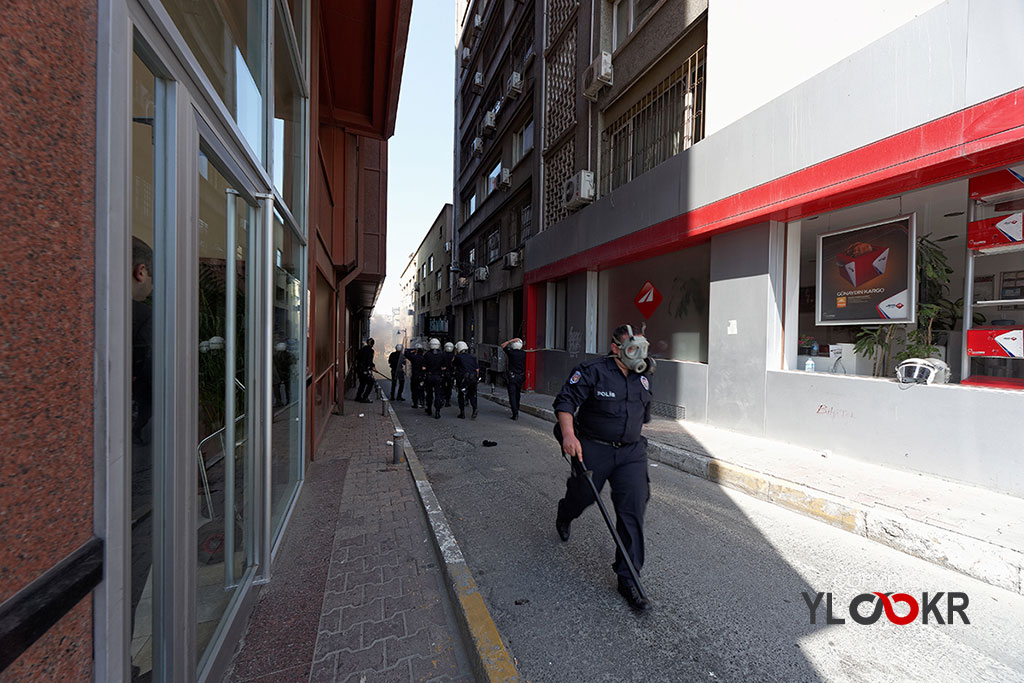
[766,371,1024,497]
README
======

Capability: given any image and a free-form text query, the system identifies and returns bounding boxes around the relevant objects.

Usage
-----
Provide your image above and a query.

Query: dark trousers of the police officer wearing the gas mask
[558,436,650,583]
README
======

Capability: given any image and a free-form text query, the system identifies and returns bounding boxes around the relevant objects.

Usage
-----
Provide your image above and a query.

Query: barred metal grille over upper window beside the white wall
[601,47,705,194]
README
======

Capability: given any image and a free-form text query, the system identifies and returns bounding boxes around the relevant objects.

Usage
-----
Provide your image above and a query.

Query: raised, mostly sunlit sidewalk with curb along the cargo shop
[480,387,1024,594]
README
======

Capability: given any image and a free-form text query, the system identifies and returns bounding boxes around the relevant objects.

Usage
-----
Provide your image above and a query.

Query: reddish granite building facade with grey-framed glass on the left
[0,0,412,682]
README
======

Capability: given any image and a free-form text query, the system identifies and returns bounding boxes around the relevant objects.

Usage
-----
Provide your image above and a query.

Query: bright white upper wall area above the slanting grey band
[706,0,942,134]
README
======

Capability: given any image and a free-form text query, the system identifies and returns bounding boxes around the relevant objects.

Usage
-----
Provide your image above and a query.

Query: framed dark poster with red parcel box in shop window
[816,214,916,325]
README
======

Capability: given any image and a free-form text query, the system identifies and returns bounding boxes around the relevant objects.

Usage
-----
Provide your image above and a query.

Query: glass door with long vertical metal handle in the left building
[196,150,258,664]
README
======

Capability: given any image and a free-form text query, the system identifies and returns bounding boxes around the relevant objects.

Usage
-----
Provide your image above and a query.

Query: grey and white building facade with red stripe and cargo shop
[524,0,1024,496]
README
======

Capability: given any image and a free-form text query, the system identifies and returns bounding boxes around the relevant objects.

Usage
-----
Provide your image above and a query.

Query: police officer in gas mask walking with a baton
[554,325,653,610]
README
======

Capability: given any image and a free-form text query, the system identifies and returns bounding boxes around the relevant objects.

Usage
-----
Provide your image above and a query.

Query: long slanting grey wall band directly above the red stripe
[525,0,1024,269]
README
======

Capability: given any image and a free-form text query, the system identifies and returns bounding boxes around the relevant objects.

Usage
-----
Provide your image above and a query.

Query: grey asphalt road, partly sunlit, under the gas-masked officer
[382,385,1024,683]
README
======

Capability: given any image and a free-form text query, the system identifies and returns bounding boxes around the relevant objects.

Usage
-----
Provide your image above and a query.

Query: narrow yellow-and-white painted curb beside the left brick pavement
[388,404,520,683]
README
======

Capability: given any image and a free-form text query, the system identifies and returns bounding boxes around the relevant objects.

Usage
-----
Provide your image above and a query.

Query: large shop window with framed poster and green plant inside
[786,180,1011,382]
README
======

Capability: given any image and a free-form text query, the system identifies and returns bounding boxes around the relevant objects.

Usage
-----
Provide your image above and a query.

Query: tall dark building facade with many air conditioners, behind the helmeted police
[452,0,543,379]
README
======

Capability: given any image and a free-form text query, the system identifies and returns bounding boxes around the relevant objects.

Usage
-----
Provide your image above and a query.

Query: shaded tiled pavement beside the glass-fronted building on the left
[227,402,473,683]
